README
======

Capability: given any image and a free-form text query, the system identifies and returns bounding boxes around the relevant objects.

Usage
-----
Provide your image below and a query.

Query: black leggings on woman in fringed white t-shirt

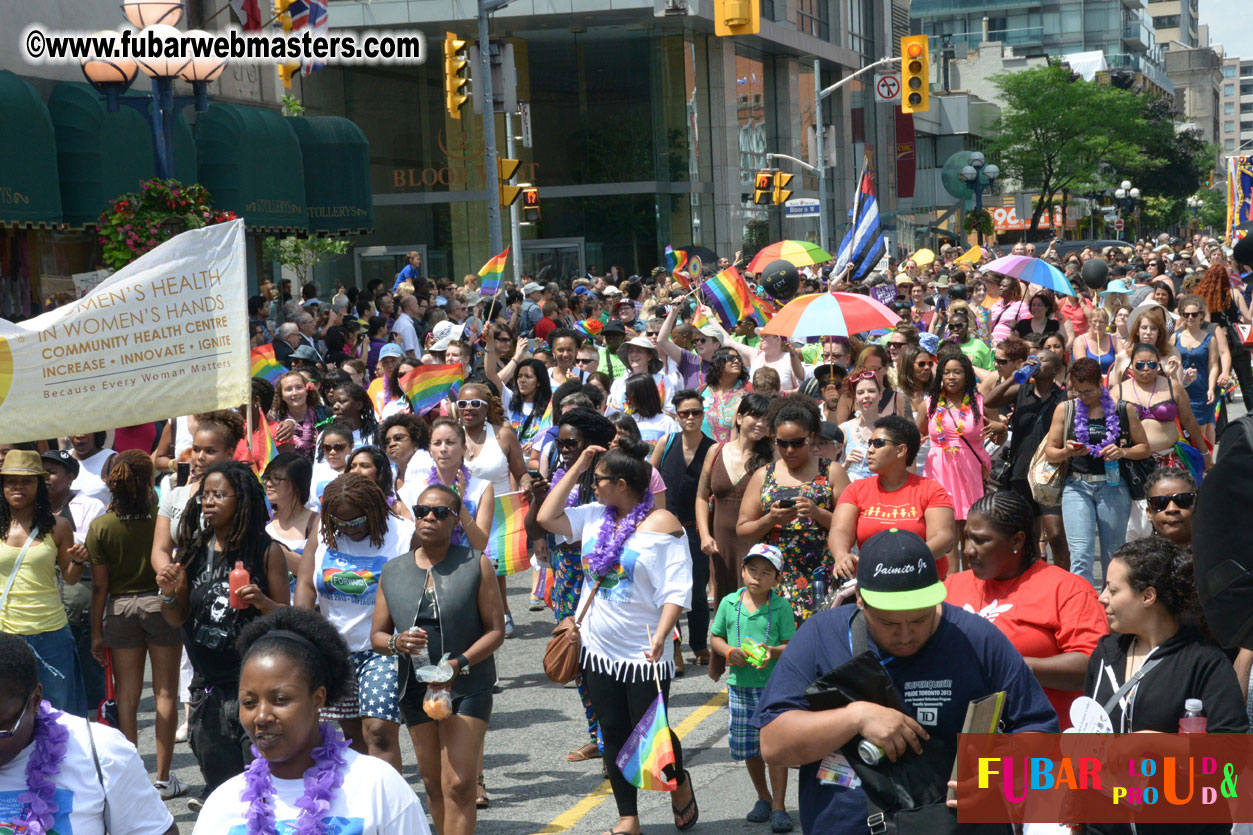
[583,664,683,817]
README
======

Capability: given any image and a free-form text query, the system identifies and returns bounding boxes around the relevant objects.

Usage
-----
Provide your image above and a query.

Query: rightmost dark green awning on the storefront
[287,117,375,234]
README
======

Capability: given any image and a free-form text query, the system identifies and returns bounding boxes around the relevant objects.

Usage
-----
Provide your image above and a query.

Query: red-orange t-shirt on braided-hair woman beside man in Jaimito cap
[944,559,1109,731]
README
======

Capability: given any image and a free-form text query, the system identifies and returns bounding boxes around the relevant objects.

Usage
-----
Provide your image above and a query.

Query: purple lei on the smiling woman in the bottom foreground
[239,722,348,835]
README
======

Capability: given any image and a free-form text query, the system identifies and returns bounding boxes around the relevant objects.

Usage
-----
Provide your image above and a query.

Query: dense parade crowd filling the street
[0,228,1253,835]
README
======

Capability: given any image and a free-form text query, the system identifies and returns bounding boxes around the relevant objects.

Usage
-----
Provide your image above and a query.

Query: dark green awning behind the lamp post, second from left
[48,81,195,227]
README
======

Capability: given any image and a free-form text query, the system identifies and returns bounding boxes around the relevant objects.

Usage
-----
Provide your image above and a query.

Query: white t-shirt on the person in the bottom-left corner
[0,713,174,835]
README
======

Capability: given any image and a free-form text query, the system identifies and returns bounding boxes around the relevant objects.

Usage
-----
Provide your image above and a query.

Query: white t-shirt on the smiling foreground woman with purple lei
[190,748,431,835]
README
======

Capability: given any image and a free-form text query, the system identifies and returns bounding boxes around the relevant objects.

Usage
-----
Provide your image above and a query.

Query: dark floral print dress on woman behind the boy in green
[762,458,834,627]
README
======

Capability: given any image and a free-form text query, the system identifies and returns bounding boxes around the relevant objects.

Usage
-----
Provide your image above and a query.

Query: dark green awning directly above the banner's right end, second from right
[195,102,308,233]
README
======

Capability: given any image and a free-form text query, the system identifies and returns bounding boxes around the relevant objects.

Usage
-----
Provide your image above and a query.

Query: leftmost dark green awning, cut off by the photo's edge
[0,70,61,226]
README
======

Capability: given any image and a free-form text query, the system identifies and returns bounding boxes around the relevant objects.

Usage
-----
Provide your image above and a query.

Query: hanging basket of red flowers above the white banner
[98,179,236,270]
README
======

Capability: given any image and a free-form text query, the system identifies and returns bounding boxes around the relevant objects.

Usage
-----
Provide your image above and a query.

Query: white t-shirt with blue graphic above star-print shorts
[313,517,413,652]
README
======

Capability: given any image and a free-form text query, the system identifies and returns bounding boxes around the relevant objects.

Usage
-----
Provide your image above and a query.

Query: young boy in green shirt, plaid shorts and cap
[709,539,796,832]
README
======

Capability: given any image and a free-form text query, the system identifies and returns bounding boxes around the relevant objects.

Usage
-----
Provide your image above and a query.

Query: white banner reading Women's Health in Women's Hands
[0,221,251,444]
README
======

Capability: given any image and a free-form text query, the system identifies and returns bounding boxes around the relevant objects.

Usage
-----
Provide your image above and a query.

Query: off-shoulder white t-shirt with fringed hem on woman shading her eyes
[559,502,692,681]
